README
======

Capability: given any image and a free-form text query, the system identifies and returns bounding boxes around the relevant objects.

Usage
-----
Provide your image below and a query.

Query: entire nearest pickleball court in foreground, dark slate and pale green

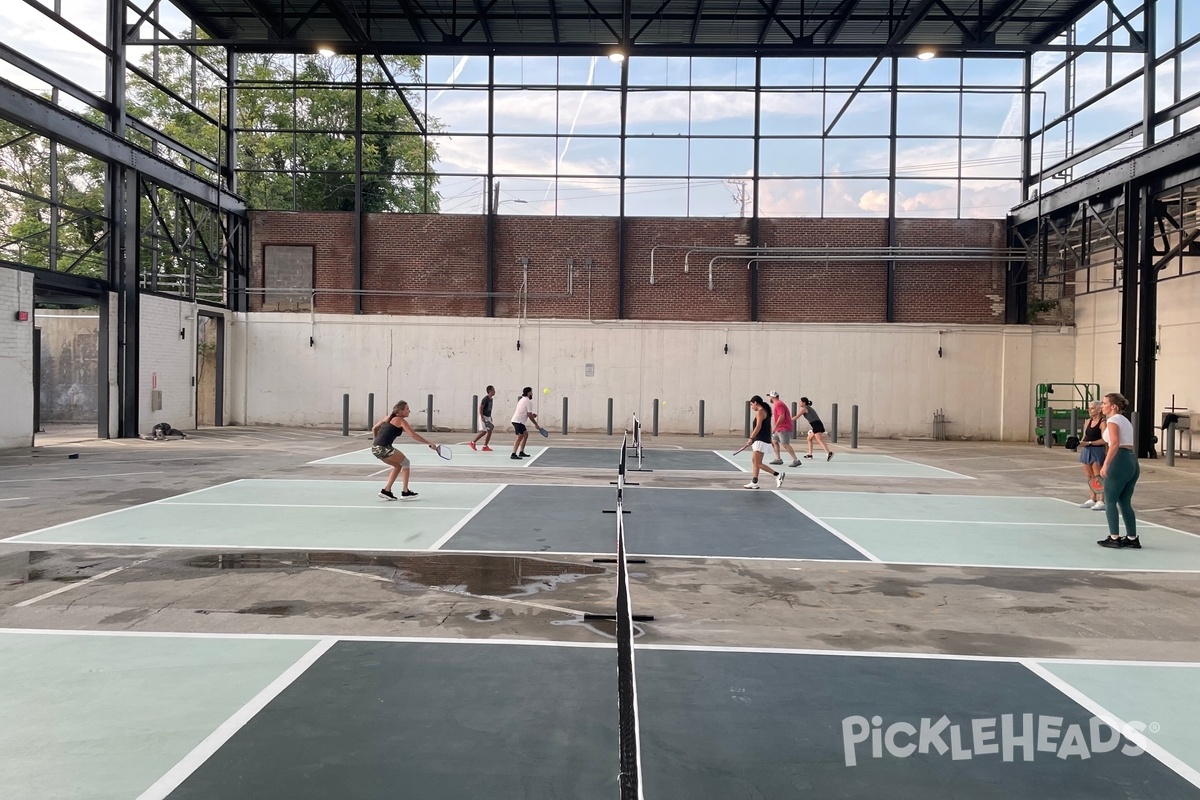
[0,630,1200,800]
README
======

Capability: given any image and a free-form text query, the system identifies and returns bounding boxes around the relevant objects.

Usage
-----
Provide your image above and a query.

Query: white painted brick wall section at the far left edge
[0,267,34,450]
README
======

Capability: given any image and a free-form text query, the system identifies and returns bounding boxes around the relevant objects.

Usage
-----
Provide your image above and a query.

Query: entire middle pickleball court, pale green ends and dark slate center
[5,479,1200,571]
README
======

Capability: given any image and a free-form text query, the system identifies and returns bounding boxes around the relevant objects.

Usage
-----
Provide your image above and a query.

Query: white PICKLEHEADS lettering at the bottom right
[841,714,1158,766]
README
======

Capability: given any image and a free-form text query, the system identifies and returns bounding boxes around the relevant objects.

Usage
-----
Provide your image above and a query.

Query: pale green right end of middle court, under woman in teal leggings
[784,492,1200,571]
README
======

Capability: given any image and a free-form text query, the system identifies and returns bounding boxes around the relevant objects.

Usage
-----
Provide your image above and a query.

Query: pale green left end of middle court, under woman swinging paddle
[7,480,502,551]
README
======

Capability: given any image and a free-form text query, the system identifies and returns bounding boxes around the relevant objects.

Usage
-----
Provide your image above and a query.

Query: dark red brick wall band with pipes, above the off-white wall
[251,212,1004,324]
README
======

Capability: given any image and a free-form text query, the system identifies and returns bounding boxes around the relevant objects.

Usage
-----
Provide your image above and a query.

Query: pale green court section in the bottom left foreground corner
[0,631,318,800]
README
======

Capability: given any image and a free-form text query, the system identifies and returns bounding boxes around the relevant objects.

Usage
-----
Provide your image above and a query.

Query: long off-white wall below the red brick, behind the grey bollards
[229,313,1075,440]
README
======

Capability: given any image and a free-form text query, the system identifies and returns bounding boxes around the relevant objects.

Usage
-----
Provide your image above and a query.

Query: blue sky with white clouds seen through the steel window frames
[0,0,1200,217]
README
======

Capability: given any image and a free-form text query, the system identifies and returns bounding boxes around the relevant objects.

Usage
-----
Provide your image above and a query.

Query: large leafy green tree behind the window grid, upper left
[127,47,439,212]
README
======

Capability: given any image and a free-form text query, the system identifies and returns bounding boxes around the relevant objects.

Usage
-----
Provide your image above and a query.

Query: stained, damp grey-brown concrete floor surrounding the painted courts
[0,427,1200,661]
